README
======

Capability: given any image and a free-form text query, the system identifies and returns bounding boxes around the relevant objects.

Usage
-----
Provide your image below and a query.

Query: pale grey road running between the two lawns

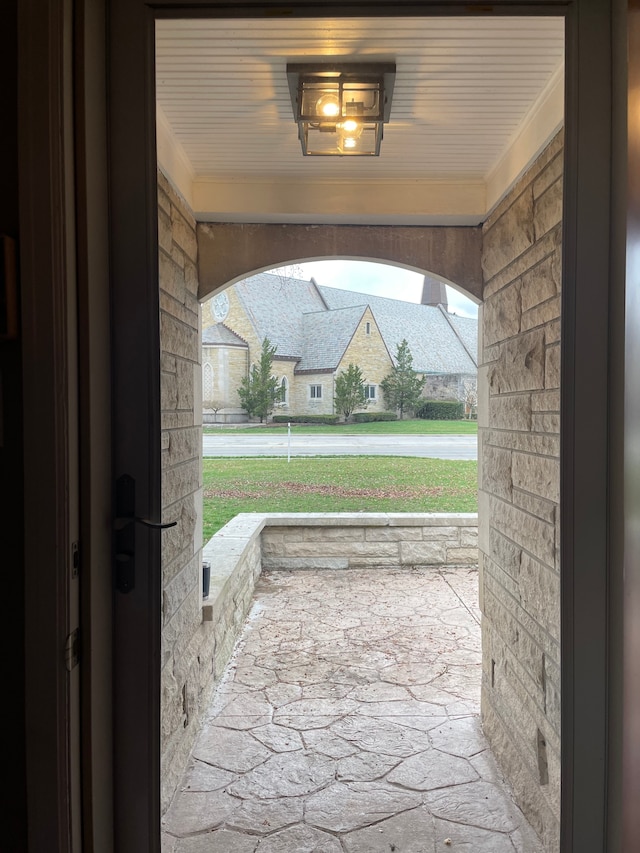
[202,430,478,459]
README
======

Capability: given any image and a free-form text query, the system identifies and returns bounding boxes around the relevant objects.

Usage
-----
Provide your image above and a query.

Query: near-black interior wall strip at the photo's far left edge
[0,0,26,853]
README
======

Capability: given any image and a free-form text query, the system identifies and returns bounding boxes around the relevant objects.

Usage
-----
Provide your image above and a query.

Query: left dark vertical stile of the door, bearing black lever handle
[109,0,161,853]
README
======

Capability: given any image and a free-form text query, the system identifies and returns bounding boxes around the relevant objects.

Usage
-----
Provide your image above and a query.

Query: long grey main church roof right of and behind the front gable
[318,285,477,373]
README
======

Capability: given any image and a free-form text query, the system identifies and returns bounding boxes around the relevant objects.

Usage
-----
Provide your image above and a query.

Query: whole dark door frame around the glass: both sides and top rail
[109,0,611,853]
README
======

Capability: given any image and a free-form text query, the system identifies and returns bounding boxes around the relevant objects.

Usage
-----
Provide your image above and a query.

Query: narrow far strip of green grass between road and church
[204,418,478,435]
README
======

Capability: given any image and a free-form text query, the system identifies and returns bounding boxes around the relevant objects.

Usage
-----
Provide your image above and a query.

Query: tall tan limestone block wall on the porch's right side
[478,135,563,853]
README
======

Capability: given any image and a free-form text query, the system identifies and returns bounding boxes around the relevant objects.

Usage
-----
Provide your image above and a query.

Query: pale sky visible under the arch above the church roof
[268,261,478,317]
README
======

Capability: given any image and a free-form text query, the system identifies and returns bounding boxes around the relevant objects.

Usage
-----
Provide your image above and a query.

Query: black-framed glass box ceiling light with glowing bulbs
[287,62,396,157]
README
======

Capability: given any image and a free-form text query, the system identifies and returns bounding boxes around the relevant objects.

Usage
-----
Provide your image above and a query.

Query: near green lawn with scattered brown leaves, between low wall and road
[203,456,478,542]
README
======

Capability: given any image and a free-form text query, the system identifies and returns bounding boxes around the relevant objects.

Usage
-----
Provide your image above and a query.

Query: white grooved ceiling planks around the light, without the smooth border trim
[156,17,564,223]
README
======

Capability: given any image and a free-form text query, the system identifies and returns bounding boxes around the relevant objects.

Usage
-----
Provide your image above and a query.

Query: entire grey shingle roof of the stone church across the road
[228,273,478,374]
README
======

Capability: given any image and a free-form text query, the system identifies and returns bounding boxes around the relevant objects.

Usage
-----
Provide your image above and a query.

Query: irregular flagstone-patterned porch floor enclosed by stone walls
[163,569,542,853]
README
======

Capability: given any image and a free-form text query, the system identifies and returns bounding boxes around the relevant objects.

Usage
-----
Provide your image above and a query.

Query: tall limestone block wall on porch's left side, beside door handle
[158,168,211,807]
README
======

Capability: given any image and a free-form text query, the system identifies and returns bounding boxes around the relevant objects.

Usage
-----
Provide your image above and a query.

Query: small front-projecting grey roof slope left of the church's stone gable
[296,305,367,373]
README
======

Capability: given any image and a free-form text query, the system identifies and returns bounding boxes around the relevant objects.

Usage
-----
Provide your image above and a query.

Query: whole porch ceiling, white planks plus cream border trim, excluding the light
[156,17,564,225]
